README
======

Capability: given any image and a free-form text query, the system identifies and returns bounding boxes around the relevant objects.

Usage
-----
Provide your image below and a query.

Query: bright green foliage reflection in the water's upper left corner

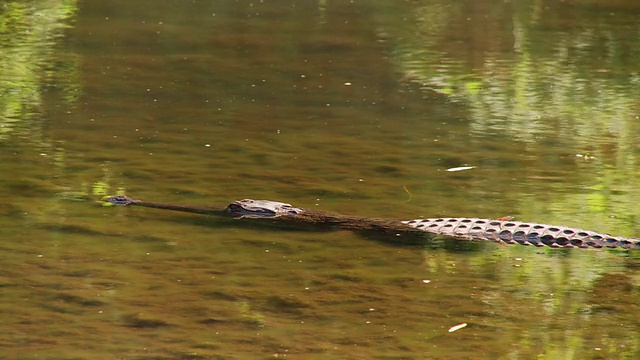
[0,0,78,142]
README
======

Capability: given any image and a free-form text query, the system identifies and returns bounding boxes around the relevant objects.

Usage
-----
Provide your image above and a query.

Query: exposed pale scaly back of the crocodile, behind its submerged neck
[403,218,640,249]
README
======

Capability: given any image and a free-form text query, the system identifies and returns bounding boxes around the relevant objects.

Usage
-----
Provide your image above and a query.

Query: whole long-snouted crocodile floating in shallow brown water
[105,195,640,250]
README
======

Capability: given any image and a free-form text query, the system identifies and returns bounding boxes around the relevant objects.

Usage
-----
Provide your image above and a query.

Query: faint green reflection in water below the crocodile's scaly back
[422,248,640,359]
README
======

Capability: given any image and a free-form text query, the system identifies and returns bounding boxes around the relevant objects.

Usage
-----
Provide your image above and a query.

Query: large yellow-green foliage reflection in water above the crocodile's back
[378,0,640,236]
